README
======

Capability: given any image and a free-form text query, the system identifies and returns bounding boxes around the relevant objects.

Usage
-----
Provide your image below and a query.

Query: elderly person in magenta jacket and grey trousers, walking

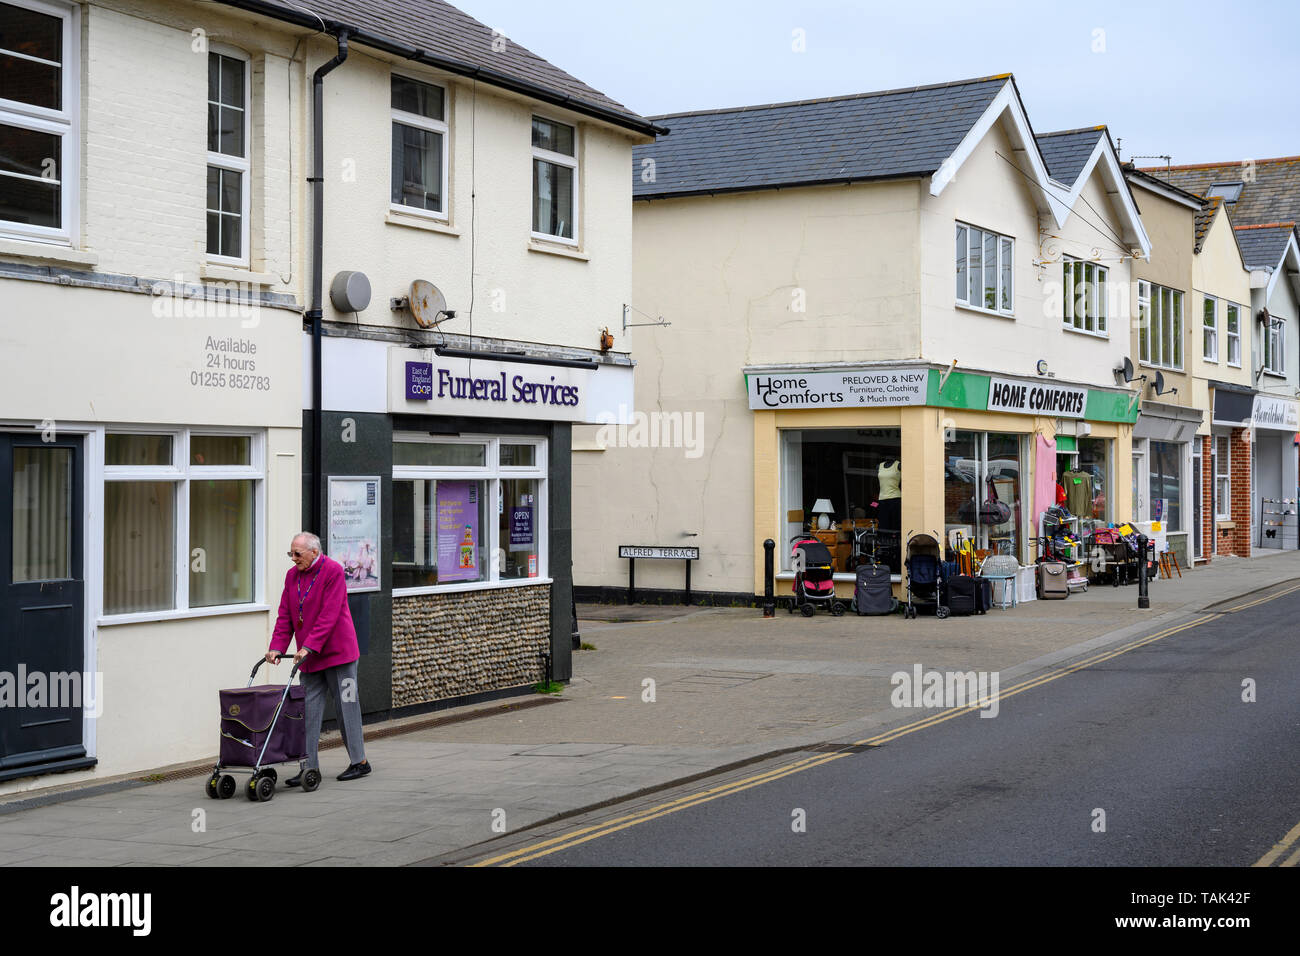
[267,531,371,787]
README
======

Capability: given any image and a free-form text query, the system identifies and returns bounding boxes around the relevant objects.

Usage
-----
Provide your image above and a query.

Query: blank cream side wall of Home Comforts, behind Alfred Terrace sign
[573,181,919,593]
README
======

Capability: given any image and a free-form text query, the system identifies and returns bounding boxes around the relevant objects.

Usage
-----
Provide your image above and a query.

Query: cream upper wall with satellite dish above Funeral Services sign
[310,42,642,351]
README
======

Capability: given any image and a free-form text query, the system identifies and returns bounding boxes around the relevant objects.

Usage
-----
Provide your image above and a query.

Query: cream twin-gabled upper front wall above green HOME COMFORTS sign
[920,125,1130,386]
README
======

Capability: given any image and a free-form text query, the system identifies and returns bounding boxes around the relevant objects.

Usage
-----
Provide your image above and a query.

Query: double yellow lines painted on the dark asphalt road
[472,584,1300,866]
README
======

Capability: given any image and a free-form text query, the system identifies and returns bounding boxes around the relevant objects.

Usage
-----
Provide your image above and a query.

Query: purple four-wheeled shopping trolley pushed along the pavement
[204,654,321,801]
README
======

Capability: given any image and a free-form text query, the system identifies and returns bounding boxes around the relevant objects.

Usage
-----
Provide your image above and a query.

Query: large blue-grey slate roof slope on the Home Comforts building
[633,74,1013,199]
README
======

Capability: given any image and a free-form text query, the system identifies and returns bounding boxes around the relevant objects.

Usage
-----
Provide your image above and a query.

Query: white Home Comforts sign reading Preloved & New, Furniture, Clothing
[746,368,930,410]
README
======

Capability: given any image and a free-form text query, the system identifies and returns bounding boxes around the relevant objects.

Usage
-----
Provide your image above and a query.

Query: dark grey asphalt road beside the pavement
[465,588,1300,866]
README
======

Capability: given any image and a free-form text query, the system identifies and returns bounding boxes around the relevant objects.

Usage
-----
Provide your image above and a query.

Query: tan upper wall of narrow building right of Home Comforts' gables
[1128,181,1204,407]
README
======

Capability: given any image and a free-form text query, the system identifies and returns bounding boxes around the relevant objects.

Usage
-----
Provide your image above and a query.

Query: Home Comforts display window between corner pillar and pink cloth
[944,429,1026,557]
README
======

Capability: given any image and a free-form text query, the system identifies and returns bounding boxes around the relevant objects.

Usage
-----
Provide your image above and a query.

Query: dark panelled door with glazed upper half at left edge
[0,433,87,780]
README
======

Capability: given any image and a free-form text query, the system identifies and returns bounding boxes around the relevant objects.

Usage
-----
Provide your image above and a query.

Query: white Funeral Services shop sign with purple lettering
[389,349,594,421]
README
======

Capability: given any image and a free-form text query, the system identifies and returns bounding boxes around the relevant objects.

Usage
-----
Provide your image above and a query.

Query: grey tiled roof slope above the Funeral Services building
[218,0,651,131]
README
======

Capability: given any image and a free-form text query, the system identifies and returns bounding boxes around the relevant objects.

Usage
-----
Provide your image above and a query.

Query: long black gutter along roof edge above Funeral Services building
[217,0,668,137]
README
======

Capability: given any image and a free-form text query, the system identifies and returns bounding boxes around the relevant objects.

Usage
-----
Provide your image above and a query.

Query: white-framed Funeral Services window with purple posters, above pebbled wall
[393,434,547,593]
